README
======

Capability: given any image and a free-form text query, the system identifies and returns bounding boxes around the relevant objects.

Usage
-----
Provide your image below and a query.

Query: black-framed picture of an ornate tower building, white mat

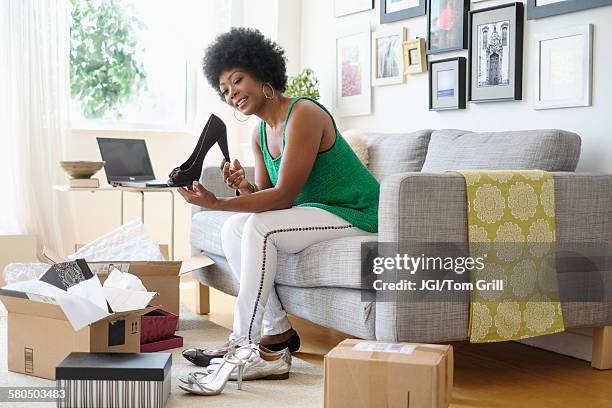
[469,3,524,102]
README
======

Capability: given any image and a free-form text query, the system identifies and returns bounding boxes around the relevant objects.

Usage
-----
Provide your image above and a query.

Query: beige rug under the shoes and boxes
[0,307,323,408]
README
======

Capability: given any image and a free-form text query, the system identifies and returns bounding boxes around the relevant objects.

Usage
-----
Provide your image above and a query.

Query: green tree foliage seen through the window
[70,0,147,119]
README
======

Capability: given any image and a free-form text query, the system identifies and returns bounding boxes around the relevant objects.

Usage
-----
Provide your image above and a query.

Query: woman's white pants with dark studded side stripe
[221,207,376,343]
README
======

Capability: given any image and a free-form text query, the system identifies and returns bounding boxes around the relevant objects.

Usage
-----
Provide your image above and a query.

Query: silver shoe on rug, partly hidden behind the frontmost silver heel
[206,345,291,381]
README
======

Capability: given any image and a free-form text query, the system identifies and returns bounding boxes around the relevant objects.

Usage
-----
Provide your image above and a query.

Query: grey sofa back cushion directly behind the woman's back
[365,130,431,182]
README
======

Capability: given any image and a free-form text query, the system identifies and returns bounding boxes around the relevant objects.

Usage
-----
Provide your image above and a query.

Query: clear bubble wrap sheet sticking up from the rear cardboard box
[68,219,164,262]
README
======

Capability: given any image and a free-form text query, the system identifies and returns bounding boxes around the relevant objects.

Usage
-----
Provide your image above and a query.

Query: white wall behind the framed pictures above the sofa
[300,0,612,173]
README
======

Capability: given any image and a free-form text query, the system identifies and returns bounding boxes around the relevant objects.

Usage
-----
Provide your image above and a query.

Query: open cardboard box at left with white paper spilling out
[0,291,157,380]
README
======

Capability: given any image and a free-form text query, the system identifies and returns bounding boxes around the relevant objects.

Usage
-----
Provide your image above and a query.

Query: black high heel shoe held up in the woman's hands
[168,115,230,187]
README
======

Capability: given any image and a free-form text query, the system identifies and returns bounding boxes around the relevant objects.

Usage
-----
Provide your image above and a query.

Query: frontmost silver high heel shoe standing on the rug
[178,345,255,395]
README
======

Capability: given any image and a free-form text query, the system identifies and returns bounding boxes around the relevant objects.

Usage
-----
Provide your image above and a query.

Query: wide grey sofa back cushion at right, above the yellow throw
[422,130,580,173]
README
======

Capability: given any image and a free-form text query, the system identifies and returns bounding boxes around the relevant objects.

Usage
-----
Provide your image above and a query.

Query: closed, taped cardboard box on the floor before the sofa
[324,339,453,408]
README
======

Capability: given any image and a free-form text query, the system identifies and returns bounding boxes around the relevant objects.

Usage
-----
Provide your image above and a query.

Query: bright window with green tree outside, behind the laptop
[71,0,229,130]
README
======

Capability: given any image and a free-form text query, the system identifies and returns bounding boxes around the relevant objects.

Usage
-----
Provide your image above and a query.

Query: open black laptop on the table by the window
[96,137,169,188]
